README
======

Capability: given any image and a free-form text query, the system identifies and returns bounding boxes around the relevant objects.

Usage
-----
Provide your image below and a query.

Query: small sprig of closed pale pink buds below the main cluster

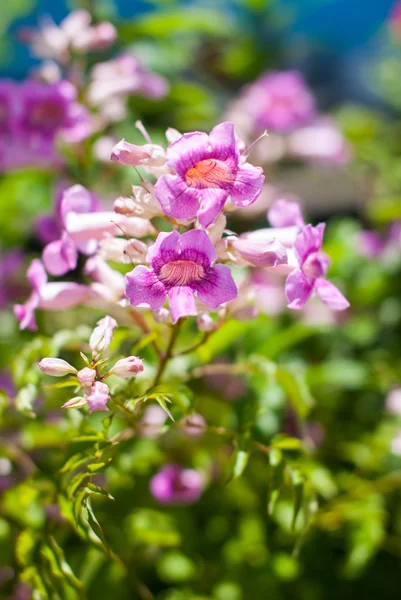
[39,316,143,413]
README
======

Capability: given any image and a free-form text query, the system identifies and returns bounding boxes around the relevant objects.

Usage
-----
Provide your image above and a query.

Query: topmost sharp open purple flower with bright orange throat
[155,122,264,227]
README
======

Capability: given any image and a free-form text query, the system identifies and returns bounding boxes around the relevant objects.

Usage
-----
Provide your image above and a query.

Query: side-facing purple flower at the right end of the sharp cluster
[285,223,349,310]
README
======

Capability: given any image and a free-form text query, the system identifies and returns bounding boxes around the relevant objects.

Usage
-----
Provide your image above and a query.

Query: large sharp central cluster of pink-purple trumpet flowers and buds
[16,117,349,332]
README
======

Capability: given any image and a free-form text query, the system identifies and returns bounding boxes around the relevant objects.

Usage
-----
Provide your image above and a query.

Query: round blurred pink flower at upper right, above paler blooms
[239,71,316,132]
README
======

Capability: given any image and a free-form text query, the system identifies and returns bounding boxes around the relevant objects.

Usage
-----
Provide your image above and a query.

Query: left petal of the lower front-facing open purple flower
[125,265,166,310]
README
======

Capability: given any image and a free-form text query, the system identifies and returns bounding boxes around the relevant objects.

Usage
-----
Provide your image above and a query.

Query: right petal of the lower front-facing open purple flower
[193,265,238,308]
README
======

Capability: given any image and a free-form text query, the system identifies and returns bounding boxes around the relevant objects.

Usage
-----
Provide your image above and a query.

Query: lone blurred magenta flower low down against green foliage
[150,464,205,505]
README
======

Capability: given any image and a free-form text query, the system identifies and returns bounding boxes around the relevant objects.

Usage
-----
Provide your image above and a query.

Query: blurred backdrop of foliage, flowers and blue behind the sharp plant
[0,0,401,600]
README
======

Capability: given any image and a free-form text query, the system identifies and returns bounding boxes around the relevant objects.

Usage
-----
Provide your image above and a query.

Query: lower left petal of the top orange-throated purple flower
[155,175,200,220]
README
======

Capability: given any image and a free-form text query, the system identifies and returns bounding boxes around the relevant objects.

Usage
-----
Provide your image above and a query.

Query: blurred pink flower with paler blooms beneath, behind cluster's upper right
[226,71,350,165]
